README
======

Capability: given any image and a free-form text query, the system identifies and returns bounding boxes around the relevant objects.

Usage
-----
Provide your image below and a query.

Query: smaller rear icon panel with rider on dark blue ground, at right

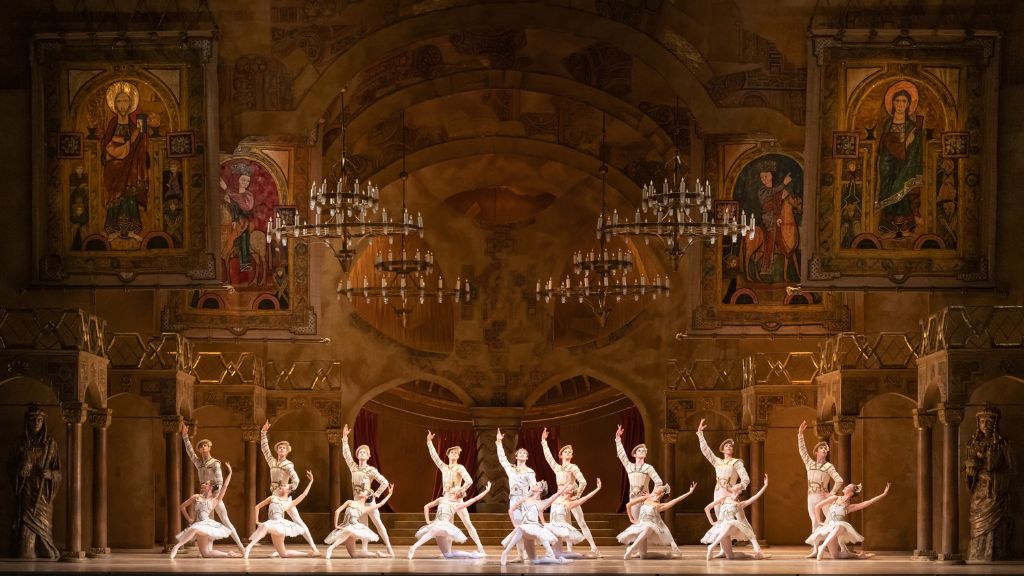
[693,135,850,331]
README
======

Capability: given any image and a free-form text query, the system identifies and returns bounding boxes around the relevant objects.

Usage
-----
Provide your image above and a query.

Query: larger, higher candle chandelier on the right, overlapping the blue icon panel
[597,144,755,271]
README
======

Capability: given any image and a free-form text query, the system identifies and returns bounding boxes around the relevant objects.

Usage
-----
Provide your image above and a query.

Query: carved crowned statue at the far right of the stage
[964,403,1013,562]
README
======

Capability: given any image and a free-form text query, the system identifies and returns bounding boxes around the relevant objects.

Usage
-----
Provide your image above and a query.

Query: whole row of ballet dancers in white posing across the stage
[170,420,889,565]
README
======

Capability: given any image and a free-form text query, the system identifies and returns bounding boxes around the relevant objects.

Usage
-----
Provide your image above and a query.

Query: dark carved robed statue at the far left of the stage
[11,404,60,559]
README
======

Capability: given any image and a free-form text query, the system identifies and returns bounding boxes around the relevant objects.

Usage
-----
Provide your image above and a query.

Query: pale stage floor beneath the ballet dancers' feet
[0,546,1024,575]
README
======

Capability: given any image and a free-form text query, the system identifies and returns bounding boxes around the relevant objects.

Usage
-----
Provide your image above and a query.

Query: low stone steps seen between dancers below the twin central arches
[378,512,629,541]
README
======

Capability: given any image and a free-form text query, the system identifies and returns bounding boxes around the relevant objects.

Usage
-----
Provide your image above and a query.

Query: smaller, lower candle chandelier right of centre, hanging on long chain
[537,118,671,328]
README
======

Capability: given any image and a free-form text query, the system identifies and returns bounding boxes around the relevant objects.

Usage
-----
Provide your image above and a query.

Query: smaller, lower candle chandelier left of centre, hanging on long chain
[337,113,472,328]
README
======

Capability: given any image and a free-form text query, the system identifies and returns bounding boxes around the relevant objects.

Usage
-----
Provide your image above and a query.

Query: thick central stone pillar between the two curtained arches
[468,406,524,512]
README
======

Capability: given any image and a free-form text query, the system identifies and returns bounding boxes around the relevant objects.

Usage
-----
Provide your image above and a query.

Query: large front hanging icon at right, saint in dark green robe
[809,30,995,284]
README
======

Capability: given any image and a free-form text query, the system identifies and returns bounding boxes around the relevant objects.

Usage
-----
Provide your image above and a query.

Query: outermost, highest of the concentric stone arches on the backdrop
[242,3,802,141]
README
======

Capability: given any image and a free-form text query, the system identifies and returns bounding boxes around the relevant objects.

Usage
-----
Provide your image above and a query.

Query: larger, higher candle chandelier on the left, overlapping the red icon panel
[266,90,423,273]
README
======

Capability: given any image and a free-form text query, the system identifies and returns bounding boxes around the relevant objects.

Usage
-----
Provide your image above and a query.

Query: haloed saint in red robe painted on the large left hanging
[99,82,150,241]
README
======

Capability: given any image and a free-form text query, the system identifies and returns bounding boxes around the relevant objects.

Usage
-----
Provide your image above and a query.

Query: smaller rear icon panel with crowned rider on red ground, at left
[163,138,315,334]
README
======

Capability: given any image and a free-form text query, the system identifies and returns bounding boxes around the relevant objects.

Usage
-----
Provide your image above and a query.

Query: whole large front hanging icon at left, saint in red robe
[34,38,216,284]
